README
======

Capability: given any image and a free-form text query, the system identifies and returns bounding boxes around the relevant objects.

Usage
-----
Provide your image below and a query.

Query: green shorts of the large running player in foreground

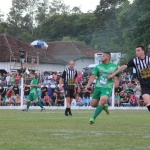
[92,87,112,100]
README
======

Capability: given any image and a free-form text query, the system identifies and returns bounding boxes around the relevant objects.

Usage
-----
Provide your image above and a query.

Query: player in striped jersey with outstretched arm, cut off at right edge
[108,46,150,111]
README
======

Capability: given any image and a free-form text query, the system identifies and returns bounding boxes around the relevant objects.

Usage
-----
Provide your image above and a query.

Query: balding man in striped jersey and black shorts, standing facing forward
[59,60,80,116]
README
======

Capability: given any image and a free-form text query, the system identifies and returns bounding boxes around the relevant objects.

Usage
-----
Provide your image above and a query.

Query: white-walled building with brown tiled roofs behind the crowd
[0,34,100,72]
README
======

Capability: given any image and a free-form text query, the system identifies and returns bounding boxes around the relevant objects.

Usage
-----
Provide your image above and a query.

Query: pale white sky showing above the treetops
[0,0,100,14]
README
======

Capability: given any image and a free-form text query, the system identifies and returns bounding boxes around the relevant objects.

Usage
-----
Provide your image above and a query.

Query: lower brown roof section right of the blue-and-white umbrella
[47,41,101,61]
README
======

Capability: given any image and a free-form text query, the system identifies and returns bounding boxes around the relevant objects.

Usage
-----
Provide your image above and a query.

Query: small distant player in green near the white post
[22,74,45,111]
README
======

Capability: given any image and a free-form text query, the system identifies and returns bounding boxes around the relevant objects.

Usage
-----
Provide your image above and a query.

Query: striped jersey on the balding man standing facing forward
[61,68,77,89]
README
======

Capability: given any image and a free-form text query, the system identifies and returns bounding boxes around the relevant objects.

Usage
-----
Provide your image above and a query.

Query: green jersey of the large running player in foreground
[92,63,120,88]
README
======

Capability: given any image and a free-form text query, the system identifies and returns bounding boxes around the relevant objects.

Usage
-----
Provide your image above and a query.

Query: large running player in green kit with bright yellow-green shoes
[85,52,121,124]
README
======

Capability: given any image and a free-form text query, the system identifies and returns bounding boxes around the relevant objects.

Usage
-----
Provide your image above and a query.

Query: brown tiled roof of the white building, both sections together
[0,34,101,65]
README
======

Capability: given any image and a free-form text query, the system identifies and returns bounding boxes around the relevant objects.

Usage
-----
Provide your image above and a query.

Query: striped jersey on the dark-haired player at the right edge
[127,56,150,86]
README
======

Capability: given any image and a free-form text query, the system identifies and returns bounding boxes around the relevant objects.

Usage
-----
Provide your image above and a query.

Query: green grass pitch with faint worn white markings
[0,110,150,150]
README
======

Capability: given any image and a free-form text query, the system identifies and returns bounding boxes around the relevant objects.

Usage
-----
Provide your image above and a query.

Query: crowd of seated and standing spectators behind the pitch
[0,70,144,107]
